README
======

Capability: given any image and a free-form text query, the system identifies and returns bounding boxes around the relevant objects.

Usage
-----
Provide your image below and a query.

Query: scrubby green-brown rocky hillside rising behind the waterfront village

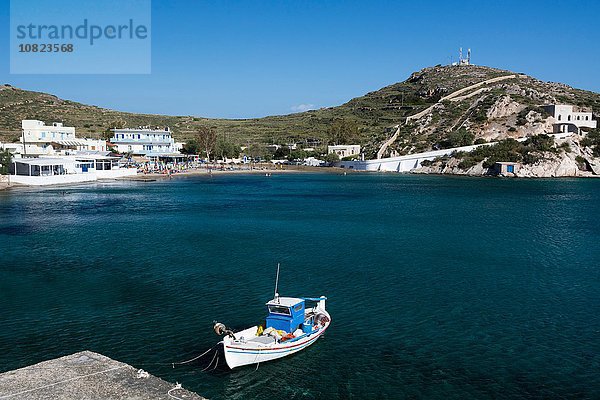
[0,65,600,162]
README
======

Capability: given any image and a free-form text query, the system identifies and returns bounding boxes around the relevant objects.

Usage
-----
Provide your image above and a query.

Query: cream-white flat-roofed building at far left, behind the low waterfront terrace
[15,119,106,157]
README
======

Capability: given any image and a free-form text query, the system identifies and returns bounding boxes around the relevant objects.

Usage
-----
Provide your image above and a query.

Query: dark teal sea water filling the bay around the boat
[0,173,600,399]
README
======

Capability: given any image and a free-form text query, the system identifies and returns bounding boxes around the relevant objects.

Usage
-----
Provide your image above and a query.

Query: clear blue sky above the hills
[0,0,600,118]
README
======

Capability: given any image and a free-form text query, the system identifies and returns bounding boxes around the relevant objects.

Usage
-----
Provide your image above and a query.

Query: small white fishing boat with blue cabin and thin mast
[213,265,331,369]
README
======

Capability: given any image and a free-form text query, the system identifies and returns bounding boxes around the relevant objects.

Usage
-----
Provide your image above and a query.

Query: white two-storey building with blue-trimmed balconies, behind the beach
[110,127,177,156]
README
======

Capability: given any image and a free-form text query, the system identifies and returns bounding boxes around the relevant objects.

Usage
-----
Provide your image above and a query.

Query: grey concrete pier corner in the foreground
[0,351,204,400]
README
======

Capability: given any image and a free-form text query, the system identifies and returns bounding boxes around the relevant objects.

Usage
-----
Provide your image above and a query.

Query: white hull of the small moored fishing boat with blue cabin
[223,310,331,369]
